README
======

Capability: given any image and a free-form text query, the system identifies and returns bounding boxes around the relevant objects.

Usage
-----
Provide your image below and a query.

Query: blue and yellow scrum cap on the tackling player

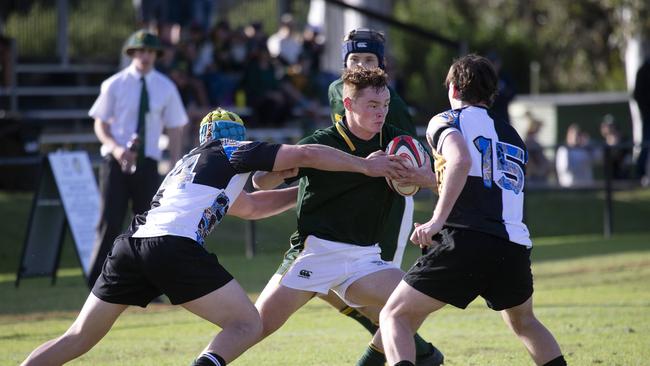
[199,108,246,145]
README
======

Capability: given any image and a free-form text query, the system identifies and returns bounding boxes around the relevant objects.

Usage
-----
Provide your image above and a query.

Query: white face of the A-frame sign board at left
[48,151,100,274]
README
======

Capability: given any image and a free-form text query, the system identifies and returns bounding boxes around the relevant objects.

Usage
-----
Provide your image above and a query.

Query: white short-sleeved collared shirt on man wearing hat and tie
[88,64,188,160]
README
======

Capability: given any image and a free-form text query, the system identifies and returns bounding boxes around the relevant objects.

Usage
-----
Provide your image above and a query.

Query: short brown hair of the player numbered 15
[445,54,498,106]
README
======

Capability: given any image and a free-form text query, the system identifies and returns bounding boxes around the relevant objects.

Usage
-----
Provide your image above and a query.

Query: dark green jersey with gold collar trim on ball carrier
[292,121,405,246]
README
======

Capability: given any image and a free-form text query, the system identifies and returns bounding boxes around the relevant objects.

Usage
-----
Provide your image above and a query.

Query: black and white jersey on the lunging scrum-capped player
[130,139,280,245]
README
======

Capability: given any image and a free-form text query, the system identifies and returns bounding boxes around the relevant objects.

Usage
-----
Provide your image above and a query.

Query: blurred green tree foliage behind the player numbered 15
[390,0,650,120]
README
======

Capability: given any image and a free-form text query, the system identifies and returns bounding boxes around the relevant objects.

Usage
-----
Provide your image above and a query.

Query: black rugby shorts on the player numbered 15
[404,227,533,310]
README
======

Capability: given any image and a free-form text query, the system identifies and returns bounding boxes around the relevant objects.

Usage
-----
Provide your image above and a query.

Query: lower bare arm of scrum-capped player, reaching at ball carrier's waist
[228,187,298,220]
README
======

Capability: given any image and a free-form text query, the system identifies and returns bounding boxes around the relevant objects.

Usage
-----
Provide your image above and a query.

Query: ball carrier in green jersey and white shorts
[254,67,443,366]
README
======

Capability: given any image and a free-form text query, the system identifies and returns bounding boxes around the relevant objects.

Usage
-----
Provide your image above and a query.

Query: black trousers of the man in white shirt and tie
[87,155,160,288]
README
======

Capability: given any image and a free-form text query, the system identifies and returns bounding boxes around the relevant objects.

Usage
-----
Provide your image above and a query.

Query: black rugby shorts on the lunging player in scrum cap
[92,235,233,307]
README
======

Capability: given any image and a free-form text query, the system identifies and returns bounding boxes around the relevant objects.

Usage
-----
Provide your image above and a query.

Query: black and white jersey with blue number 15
[427,106,532,247]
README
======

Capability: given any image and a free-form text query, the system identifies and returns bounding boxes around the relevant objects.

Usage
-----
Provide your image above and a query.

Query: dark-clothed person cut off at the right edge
[634,51,650,185]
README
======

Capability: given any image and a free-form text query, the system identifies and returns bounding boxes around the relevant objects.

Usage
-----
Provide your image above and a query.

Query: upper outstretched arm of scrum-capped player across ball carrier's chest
[273,144,402,178]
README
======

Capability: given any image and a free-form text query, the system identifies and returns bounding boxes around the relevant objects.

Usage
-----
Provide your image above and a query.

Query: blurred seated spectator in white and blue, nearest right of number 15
[555,123,596,187]
